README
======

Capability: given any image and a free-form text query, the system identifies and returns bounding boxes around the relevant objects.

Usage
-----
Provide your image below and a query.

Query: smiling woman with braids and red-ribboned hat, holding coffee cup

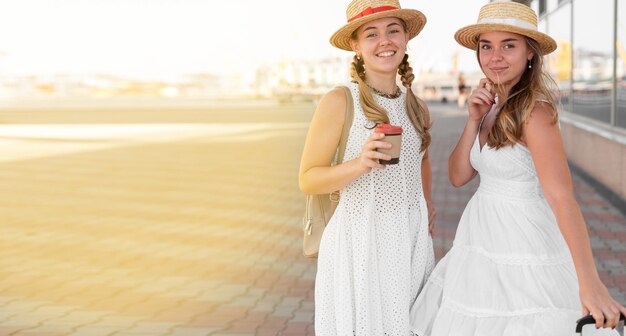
[299,0,434,336]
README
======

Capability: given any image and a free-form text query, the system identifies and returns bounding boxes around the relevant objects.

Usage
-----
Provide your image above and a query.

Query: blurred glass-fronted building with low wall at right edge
[530,0,626,202]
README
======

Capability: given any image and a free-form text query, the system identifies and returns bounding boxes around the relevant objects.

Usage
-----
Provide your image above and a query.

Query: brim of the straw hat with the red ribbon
[330,8,426,51]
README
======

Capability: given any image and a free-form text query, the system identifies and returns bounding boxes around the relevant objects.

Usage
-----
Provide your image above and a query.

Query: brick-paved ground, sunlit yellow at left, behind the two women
[0,105,626,336]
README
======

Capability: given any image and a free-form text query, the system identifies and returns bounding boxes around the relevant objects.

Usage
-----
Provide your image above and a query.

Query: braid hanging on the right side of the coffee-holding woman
[398,54,431,151]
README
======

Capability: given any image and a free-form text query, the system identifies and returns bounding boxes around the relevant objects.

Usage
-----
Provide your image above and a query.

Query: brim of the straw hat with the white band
[454,23,556,55]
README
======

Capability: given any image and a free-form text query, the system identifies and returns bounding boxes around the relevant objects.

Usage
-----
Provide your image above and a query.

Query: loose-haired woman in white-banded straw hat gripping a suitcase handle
[412,2,626,336]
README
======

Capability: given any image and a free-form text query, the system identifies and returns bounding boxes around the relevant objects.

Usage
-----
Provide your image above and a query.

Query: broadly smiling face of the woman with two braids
[350,18,409,73]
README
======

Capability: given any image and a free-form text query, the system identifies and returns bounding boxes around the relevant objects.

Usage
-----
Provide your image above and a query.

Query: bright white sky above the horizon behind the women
[0,0,488,79]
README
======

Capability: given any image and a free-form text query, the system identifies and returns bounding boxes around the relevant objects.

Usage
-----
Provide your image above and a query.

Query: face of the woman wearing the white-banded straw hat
[478,32,533,90]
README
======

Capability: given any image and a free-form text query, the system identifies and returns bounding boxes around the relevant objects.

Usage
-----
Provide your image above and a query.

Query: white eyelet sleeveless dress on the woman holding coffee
[315,83,434,336]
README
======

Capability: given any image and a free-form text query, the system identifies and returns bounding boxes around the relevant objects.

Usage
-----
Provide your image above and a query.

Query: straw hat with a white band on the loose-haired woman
[454,1,556,55]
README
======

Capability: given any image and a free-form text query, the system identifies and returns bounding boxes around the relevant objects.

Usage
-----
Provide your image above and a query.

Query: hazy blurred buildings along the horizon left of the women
[0,55,350,102]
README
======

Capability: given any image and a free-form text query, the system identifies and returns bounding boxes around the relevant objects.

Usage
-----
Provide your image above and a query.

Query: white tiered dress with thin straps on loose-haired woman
[411,106,616,336]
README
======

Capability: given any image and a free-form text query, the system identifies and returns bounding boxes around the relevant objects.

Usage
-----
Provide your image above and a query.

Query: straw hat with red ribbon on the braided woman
[330,0,426,51]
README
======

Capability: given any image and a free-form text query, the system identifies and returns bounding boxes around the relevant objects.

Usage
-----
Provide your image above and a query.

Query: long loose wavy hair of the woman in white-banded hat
[476,37,558,149]
